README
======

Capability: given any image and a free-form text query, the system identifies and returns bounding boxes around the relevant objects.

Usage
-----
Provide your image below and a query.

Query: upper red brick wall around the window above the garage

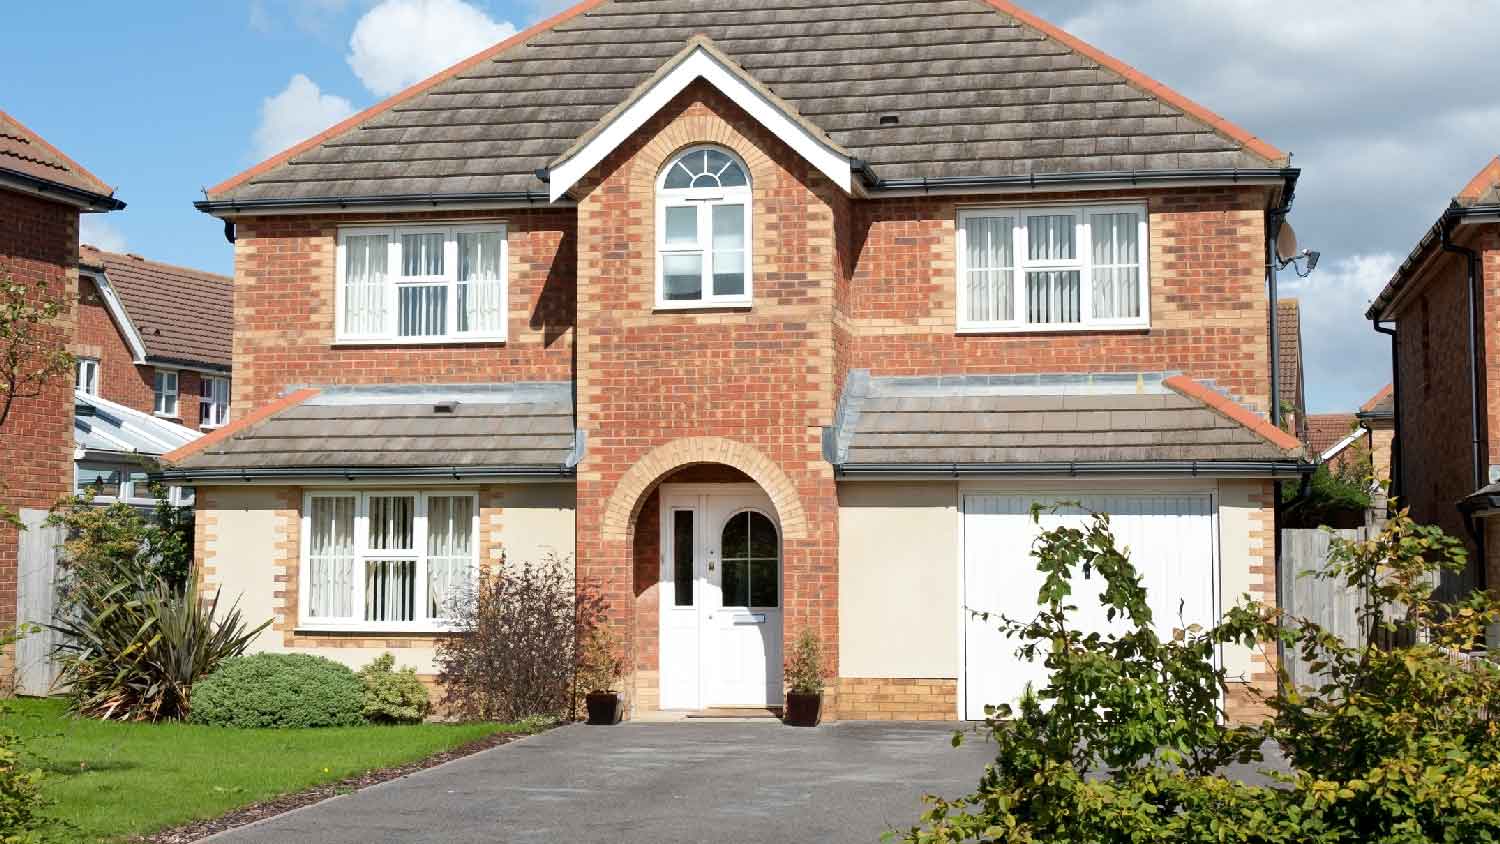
[851,187,1271,412]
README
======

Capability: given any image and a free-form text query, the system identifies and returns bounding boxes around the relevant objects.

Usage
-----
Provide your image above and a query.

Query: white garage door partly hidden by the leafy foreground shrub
[963,495,1218,720]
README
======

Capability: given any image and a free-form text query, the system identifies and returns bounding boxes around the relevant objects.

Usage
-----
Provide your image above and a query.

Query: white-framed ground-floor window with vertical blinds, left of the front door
[306,490,479,631]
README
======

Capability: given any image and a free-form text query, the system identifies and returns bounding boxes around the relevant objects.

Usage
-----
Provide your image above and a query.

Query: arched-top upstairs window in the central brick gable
[656,147,750,307]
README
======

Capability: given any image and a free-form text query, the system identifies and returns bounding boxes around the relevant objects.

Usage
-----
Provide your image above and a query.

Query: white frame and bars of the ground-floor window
[297,487,480,633]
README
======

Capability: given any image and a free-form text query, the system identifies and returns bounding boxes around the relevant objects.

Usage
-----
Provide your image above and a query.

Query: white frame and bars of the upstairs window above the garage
[954,202,1151,334]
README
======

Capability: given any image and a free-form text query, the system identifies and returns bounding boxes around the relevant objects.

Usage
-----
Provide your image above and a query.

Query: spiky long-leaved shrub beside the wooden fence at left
[53,574,270,721]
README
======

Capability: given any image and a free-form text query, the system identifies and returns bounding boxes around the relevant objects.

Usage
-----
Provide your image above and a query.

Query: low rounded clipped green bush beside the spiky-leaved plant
[192,654,365,729]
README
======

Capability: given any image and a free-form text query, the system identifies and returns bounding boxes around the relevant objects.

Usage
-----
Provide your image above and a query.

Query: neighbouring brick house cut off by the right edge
[1365,157,1500,611]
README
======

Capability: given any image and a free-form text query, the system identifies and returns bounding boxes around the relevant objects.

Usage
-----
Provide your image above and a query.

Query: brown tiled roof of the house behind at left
[78,244,234,370]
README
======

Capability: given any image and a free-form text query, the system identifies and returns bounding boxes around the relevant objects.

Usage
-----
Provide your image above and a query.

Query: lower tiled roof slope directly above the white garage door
[828,372,1304,474]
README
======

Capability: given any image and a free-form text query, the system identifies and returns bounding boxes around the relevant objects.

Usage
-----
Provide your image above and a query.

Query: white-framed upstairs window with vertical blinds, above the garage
[957,204,1151,333]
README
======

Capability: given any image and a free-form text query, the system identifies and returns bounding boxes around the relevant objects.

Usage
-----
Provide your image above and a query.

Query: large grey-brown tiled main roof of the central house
[200,0,1287,211]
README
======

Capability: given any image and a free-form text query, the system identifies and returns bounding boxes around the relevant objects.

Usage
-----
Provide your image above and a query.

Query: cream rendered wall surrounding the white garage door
[839,480,1274,679]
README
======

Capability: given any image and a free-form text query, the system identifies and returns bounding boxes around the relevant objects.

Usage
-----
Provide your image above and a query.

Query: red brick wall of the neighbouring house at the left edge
[0,190,78,635]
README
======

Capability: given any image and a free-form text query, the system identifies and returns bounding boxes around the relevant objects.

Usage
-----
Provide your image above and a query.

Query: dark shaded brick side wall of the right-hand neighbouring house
[1395,238,1488,550]
